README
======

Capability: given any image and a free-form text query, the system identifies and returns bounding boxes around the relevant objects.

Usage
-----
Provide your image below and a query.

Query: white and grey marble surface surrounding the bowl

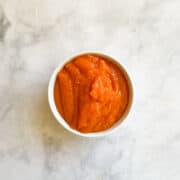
[0,0,180,180]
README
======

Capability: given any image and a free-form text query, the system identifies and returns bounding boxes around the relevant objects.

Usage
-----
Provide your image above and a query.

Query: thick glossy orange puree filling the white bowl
[54,54,129,133]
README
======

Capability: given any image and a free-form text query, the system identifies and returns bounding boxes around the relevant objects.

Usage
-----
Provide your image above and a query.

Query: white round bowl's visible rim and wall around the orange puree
[48,52,133,137]
